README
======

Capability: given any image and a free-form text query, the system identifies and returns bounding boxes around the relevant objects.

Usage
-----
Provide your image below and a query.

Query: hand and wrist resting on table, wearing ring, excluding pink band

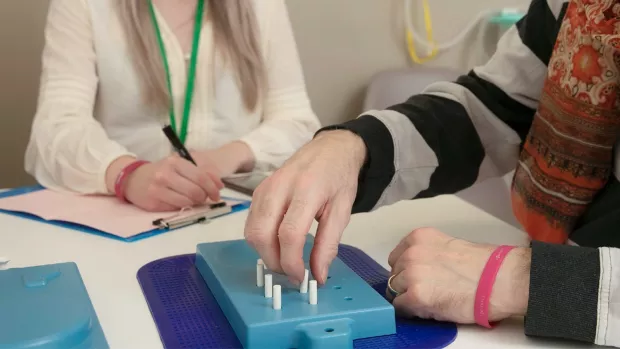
[388,228,531,324]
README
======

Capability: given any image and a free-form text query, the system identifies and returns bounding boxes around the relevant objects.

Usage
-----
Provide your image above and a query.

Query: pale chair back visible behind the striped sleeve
[363,66,519,227]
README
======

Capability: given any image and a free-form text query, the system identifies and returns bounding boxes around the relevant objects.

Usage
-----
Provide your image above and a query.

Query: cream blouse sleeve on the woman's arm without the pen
[241,0,320,170]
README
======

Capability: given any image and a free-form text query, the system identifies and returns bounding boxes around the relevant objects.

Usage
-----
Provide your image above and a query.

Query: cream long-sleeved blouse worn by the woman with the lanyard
[26,0,320,194]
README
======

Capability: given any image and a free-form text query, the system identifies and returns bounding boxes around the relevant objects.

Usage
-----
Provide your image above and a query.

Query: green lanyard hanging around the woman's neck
[148,0,205,143]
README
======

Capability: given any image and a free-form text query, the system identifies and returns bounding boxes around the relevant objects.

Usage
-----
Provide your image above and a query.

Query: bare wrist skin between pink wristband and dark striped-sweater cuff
[489,247,532,321]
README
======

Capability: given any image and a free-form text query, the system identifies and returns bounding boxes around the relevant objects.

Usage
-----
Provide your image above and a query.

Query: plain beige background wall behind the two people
[0,0,529,188]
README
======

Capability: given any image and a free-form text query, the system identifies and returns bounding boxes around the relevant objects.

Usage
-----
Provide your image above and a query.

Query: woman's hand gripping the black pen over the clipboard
[125,156,224,211]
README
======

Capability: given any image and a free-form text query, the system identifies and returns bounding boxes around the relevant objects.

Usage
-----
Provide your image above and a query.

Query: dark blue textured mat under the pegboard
[137,245,457,349]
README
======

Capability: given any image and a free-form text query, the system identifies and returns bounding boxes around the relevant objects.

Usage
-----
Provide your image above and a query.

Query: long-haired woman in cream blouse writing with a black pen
[26,0,319,211]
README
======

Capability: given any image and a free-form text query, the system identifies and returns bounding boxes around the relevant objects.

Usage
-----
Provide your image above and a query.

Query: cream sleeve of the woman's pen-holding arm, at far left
[26,0,133,194]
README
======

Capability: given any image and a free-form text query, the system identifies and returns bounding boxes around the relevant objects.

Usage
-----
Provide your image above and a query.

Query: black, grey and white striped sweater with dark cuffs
[325,0,620,347]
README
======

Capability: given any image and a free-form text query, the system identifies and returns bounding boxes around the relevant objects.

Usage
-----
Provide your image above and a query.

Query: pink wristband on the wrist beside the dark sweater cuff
[474,246,514,328]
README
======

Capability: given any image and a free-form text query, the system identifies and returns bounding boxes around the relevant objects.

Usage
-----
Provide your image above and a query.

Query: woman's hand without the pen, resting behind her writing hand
[191,142,254,178]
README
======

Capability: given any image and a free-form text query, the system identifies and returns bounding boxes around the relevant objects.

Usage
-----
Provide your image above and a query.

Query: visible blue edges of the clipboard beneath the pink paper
[0,185,250,242]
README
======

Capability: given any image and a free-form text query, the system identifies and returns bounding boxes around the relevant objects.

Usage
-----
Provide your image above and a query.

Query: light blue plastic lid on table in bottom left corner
[0,263,109,349]
